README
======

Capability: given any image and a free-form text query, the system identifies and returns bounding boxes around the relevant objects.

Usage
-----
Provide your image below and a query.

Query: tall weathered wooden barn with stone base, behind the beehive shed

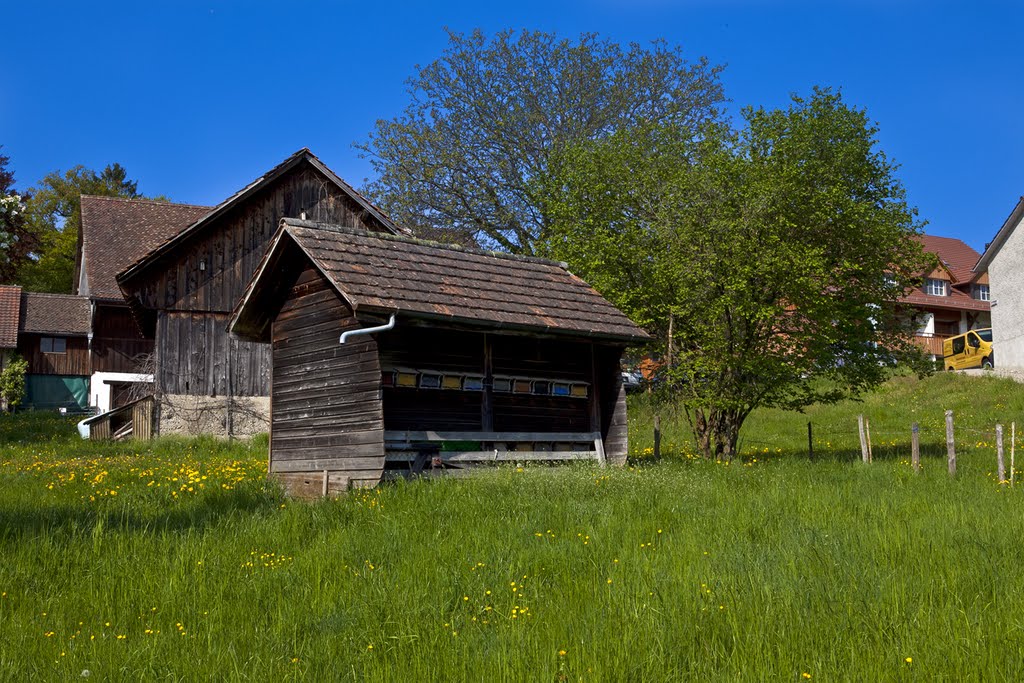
[116,148,403,434]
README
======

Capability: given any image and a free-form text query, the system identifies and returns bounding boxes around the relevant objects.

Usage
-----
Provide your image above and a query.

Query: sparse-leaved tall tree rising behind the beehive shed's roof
[357,31,724,254]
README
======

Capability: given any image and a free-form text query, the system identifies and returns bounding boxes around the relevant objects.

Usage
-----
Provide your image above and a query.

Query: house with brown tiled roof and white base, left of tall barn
[75,195,211,411]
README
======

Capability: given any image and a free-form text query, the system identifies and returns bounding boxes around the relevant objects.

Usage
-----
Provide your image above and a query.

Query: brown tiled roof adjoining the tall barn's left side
[79,195,211,299]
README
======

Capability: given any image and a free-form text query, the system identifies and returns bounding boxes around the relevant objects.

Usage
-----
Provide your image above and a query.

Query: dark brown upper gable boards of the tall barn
[135,166,389,313]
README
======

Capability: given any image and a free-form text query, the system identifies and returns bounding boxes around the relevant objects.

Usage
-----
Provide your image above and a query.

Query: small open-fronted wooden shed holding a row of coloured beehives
[229,219,648,495]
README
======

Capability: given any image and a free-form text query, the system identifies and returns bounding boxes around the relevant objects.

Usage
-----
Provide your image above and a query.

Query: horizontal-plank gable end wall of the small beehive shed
[270,267,384,486]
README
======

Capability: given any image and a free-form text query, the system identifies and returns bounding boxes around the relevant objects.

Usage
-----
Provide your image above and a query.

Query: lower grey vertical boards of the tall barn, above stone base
[156,311,270,396]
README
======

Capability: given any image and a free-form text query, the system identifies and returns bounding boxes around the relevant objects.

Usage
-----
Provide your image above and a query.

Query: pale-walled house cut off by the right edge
[975,197,1024,370]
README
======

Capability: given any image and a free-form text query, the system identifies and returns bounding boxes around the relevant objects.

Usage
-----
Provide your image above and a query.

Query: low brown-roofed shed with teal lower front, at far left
[17,292,90,409]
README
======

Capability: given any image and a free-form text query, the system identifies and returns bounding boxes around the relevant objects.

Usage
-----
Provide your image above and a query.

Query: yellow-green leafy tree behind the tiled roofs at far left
[17,164,141,293]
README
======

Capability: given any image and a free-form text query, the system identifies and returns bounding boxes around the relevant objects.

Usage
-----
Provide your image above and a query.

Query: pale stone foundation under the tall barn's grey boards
[157,394,270,438]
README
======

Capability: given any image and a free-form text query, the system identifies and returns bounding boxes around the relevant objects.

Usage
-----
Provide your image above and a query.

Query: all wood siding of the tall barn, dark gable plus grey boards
[131,165,393,396]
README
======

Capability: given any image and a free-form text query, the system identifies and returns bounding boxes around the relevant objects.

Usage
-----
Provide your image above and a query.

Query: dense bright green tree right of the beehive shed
[541,89,925,458]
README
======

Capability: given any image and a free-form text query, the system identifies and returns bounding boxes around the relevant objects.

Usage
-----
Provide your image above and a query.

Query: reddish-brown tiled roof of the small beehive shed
[232,219,648,342]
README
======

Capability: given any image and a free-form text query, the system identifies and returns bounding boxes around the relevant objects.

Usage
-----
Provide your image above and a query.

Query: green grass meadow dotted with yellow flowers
[0,375,1024,681]
